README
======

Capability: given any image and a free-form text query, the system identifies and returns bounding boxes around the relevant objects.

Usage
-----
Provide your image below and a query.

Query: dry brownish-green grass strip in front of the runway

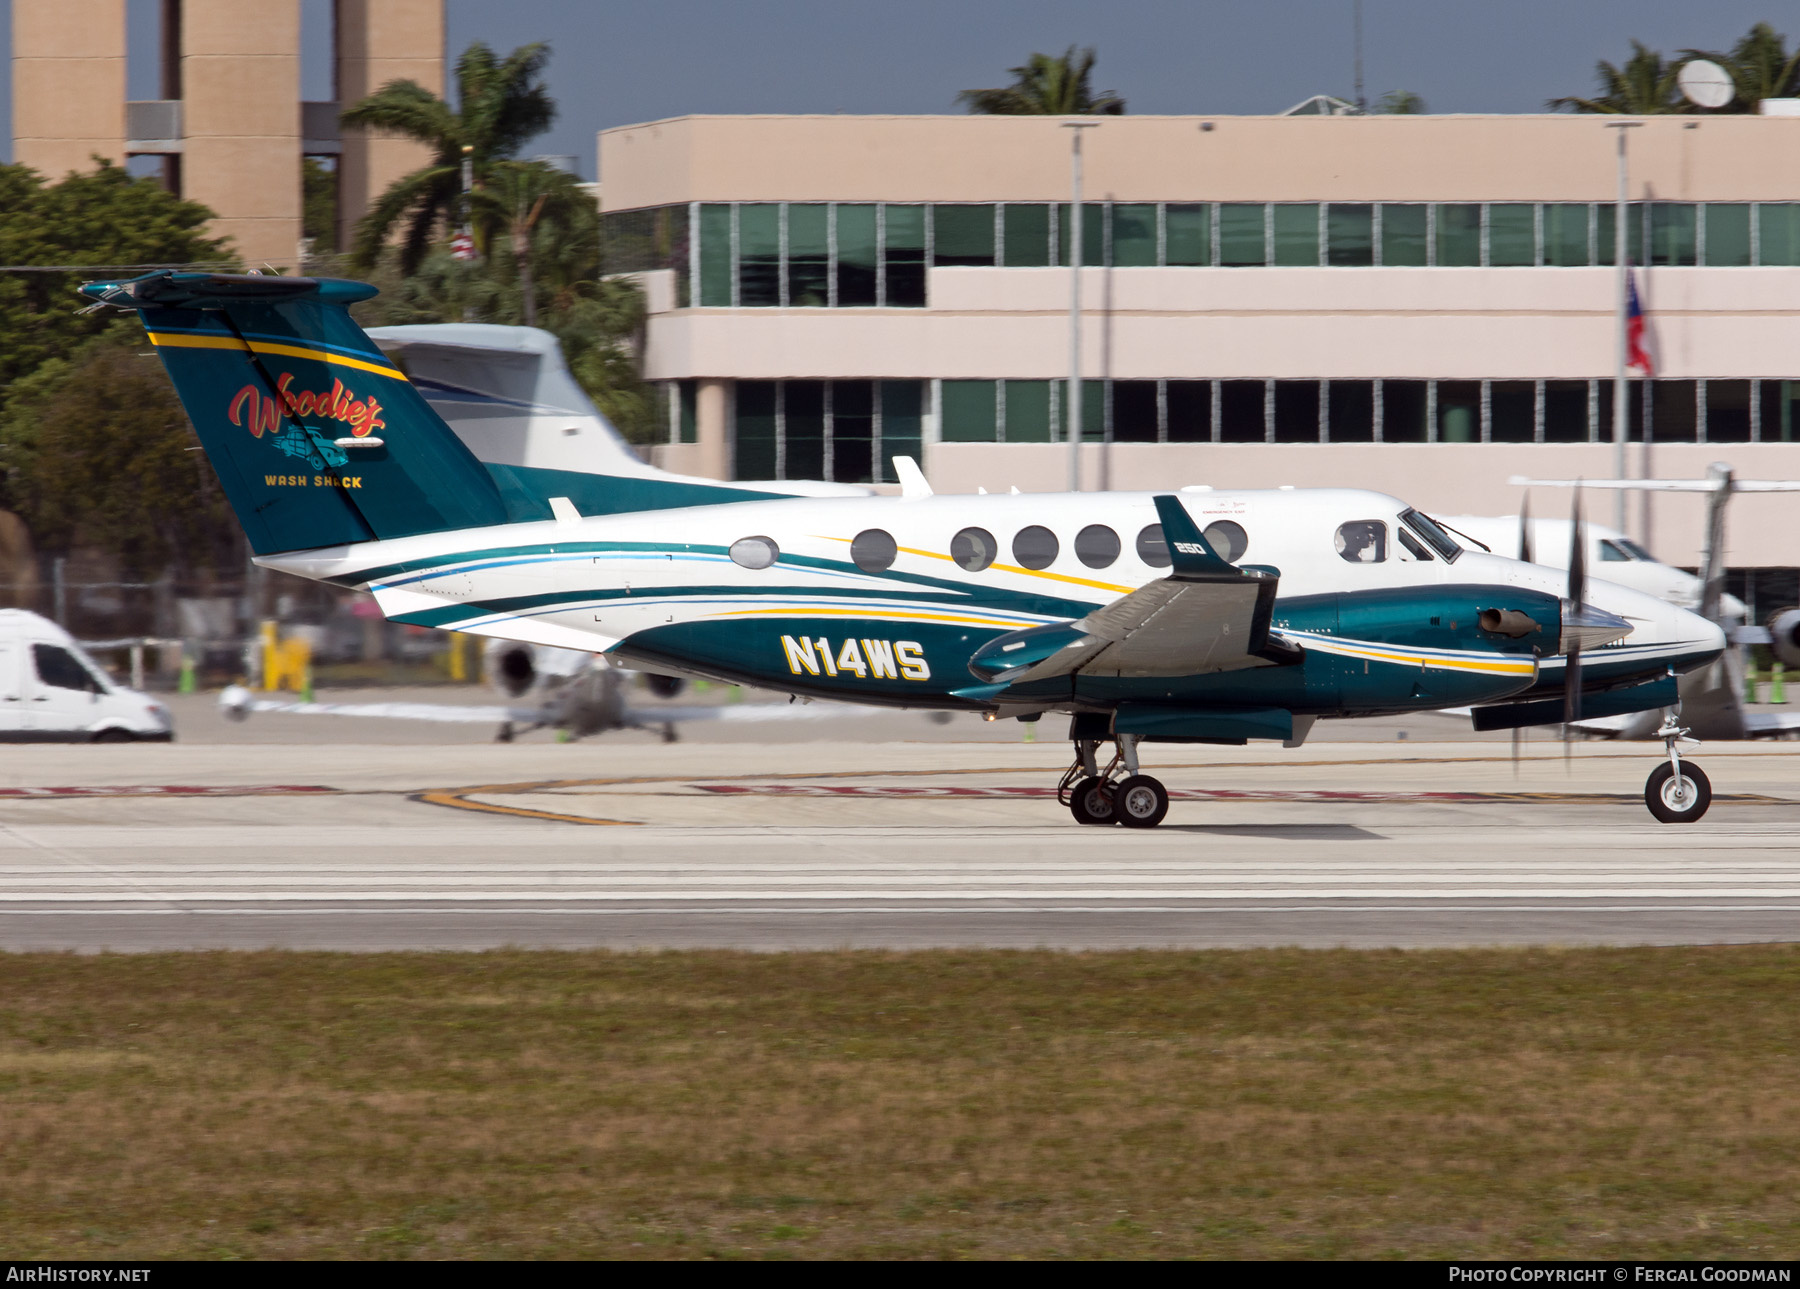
[0,945,1800,1258]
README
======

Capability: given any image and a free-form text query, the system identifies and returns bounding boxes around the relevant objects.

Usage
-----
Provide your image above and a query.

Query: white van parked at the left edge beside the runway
[0,608,175,744]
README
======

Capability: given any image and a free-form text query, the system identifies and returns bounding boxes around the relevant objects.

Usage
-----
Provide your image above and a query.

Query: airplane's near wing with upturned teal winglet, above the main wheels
[972,497,1301,684]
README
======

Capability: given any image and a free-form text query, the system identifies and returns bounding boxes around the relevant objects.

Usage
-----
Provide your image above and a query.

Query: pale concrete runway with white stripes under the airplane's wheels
[0,730,1800,951]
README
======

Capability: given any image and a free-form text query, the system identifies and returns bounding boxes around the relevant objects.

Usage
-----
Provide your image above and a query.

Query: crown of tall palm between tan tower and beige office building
[338,40,556,274]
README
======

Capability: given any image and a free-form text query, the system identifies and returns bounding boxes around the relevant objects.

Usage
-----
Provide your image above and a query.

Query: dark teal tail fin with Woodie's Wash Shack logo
[81,270,509,554]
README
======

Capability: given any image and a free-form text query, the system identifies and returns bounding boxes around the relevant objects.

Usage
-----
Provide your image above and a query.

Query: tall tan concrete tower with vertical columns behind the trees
[13,0,445,268]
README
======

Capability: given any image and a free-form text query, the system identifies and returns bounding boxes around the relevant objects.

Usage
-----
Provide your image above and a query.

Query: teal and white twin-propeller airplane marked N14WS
[81,272,1724,828]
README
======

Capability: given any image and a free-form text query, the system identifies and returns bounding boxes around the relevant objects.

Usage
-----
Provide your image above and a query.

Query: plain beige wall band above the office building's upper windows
[599,113,1800,211]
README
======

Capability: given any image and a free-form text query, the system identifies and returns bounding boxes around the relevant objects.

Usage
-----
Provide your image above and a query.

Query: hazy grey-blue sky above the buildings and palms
[0,0,1800,178]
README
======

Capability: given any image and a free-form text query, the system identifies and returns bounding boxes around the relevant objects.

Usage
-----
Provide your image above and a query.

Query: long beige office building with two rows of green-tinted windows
[599,115,1800,603]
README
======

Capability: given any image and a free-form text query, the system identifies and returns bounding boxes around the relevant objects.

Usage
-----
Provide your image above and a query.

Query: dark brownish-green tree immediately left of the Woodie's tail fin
[0,327,243,578]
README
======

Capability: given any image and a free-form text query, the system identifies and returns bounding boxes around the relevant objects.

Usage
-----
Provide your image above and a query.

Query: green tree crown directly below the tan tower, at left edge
[0,162,236,407]
